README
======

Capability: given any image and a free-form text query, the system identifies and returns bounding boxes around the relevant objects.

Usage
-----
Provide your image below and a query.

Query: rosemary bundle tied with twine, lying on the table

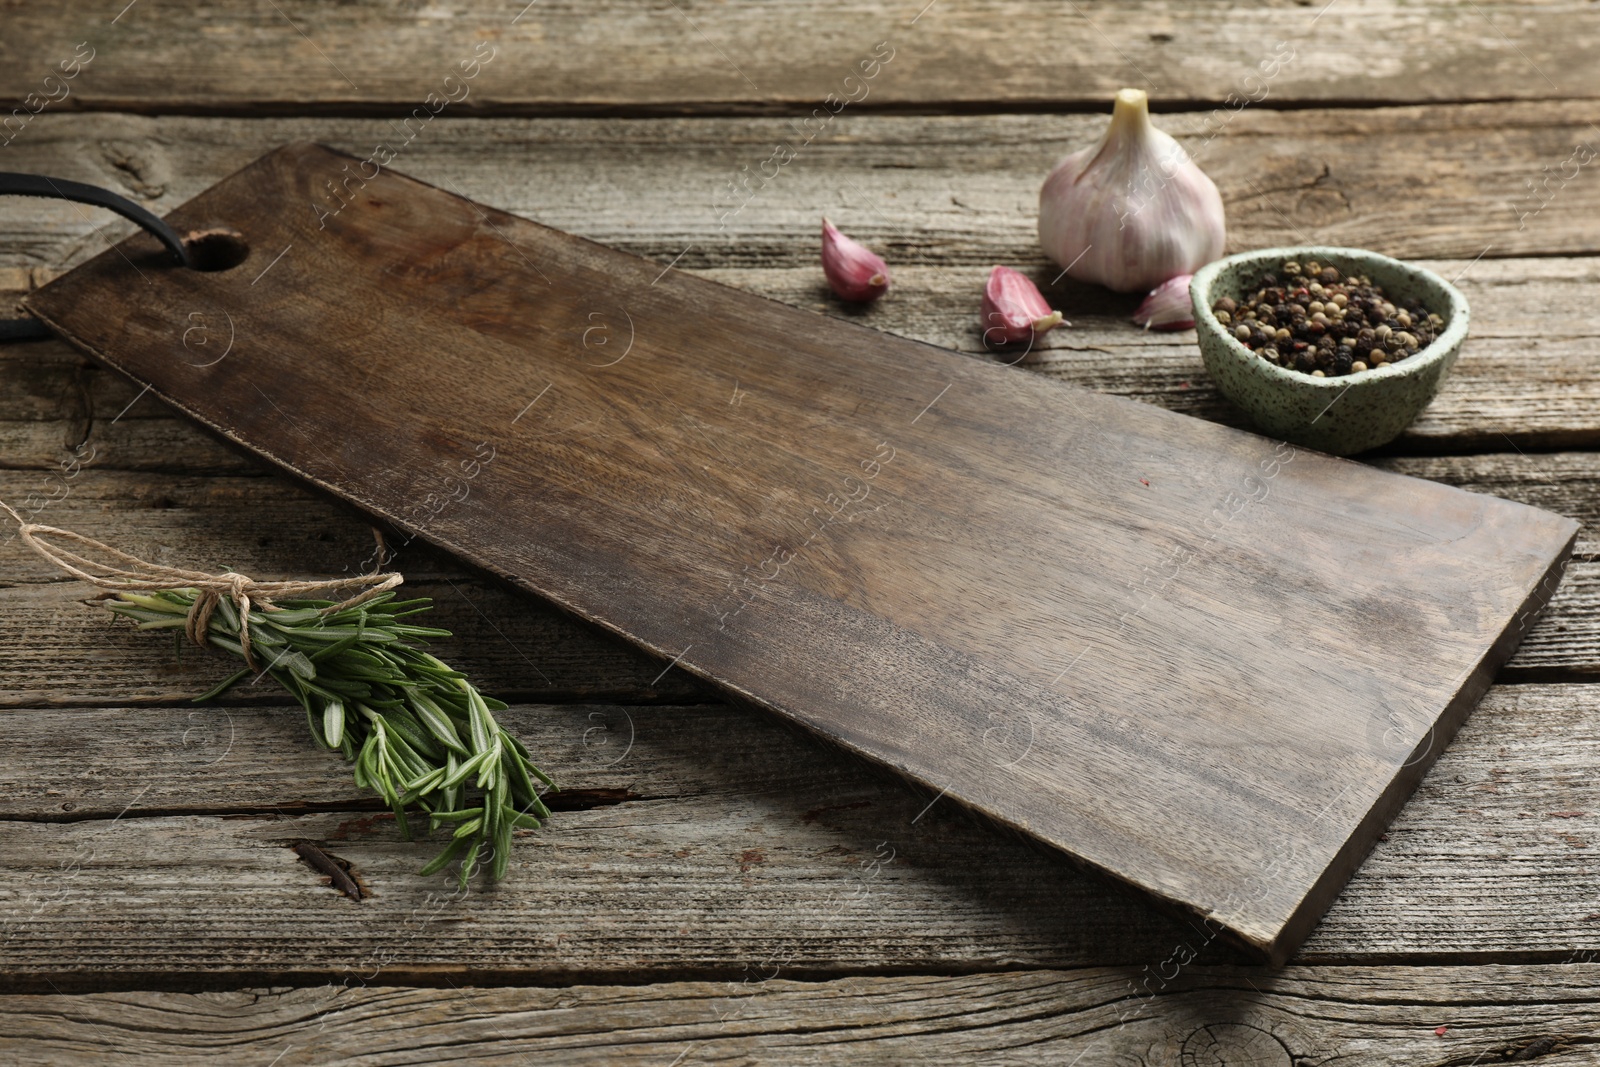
[0,501,555,888]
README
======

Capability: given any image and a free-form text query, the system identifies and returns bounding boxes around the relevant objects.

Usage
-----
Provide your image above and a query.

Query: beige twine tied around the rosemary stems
[0,501,405,670]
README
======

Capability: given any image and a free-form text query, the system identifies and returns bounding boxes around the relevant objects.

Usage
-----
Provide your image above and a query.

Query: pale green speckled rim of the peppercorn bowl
[1189,245,1470,389]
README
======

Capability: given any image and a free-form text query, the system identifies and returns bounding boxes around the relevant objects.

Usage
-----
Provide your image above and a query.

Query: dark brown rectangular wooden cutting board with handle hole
[27,144,1578,961]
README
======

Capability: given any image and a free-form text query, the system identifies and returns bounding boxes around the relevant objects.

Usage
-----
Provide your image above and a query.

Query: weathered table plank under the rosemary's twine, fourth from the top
[0,447,1600,705]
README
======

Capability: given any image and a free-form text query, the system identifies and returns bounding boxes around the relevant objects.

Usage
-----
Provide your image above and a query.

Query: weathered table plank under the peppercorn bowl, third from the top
[15,251,1600,454]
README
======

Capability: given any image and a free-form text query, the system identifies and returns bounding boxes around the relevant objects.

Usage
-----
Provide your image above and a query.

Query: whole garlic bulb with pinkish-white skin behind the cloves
[1038,90,1226,293]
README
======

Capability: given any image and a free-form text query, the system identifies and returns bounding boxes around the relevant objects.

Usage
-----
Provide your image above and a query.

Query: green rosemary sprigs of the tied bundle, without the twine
[104,589,555,886]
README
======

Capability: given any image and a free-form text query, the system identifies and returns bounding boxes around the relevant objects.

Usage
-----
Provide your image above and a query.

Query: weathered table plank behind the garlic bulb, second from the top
[0,106,1600,273]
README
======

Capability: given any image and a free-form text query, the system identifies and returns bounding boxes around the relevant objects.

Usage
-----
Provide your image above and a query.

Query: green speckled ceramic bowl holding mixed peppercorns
[1189,248,1467,456]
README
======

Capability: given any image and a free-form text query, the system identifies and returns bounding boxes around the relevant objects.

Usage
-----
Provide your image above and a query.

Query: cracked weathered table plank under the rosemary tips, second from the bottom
[0,686,1600,985]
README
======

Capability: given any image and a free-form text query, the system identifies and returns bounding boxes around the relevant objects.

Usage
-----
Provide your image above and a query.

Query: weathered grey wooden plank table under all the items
[0,0,1600,1067]
